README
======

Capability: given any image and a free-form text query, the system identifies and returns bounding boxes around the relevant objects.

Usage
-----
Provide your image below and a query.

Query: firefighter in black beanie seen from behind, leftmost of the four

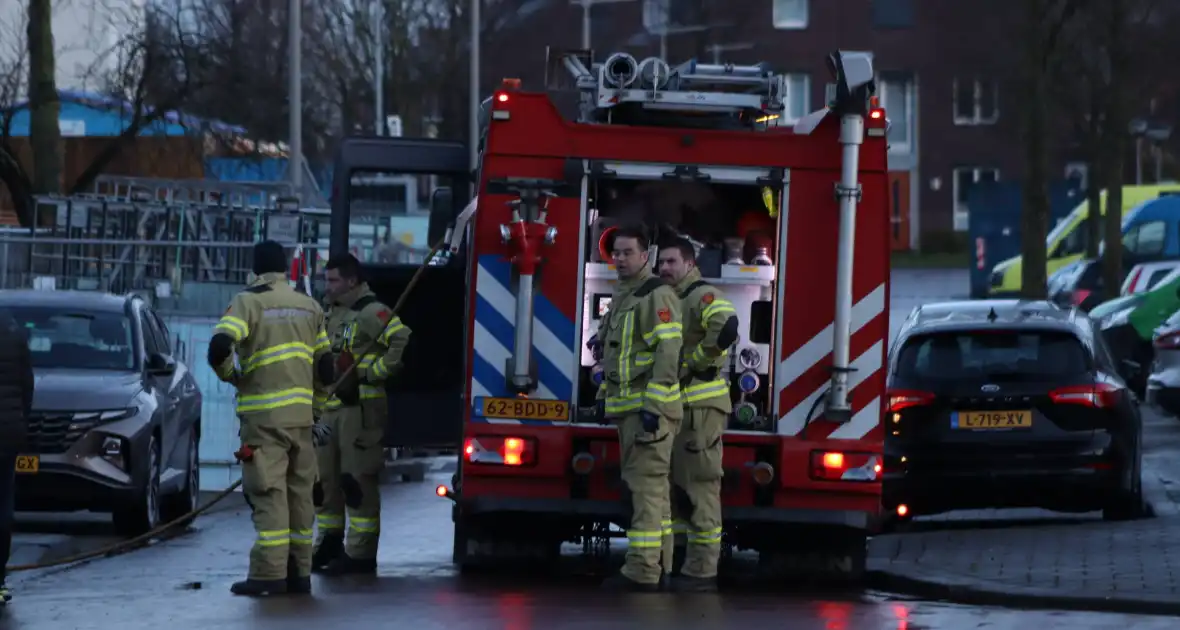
[208,241,335,596]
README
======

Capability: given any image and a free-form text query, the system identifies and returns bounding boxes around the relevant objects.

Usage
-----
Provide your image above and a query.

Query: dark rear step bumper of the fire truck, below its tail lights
[458,497,874,531]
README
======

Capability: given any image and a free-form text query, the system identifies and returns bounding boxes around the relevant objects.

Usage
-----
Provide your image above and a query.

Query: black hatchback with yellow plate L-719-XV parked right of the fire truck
[883,300,1142,519]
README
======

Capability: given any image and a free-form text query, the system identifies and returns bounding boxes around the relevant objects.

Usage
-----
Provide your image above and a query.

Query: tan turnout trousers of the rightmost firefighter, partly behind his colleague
[671,406,728,578]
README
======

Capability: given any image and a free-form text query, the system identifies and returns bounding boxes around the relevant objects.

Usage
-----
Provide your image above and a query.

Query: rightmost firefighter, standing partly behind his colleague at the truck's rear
[657,239,738,591]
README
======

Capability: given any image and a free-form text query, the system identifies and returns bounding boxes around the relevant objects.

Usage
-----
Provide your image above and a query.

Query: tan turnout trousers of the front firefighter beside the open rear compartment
[615,414,680,584]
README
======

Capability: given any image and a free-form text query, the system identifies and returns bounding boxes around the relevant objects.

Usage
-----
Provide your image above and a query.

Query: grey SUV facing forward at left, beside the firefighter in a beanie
[0,290,202,536]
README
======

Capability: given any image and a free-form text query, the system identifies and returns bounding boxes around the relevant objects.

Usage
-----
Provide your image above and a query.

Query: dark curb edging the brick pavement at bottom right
[866,560,1180,617]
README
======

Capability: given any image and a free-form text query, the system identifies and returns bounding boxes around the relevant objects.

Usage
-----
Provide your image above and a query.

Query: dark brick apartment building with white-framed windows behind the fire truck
[484,0,1067,249]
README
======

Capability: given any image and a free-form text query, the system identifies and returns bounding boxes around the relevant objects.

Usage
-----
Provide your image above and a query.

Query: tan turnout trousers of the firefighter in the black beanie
[241,409,316,580]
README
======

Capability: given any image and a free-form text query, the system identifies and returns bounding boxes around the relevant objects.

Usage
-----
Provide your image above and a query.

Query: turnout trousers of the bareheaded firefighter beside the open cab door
[316,398,387,560]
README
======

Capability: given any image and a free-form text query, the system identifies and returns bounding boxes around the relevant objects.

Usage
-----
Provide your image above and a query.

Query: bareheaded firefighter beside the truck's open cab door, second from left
[314,254,409,575]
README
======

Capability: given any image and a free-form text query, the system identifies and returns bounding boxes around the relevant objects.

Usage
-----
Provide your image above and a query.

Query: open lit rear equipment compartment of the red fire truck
[578,179,782,431]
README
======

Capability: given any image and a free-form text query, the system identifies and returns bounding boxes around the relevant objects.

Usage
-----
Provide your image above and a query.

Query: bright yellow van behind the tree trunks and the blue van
[989,184,1180,297]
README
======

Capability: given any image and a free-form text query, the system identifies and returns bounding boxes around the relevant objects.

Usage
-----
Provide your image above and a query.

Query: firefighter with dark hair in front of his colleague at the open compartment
[594,228,683,591]
